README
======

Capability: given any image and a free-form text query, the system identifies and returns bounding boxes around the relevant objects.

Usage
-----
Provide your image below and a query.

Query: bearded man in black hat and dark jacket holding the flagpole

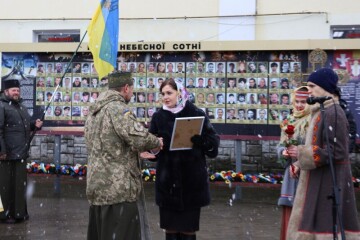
[0,78,43,223]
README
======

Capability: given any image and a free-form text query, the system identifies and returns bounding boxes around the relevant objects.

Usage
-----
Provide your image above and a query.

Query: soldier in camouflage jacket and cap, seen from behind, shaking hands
[85,72,162,240]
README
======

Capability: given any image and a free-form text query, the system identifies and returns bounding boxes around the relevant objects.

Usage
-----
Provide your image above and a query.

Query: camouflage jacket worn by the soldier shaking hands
[85,90,159,205]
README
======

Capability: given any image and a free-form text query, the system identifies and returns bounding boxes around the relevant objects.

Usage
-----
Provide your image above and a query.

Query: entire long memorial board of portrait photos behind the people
[1,51,357,136]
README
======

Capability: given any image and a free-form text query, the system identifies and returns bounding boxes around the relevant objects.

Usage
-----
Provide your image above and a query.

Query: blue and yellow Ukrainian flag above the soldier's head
[88,0,119,78]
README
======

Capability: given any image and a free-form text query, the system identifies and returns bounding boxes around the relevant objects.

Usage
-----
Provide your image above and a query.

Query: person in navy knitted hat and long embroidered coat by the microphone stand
[286,68,360,240]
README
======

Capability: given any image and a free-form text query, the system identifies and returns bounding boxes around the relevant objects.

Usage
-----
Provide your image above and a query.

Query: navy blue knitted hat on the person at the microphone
[308,68,339,93]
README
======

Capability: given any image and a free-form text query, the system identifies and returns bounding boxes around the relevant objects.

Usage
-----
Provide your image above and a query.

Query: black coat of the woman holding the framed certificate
[150,101,220,210]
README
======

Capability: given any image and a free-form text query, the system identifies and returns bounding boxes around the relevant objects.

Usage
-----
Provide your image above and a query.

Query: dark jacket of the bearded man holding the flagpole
[0,95,35,160]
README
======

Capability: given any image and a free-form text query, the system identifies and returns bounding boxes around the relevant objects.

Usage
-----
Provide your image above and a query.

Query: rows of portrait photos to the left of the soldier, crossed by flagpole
[35,62,106,121]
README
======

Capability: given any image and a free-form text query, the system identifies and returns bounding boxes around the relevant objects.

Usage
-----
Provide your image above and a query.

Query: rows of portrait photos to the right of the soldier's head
[125,61,301,124]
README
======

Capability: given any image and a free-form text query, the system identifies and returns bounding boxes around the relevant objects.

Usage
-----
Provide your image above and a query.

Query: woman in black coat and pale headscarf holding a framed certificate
[150,79,220,240]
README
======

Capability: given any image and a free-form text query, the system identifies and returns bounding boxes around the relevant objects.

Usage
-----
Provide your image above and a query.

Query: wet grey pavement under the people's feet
[0,175,360,240]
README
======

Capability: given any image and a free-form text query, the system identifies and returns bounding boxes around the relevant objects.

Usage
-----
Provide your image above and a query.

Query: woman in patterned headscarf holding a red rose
[277,86,310,240]
